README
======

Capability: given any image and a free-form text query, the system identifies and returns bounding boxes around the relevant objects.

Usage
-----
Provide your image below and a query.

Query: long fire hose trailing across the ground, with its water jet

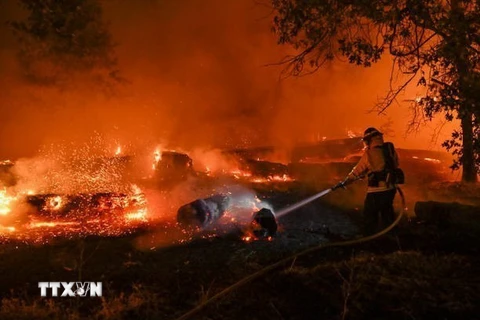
[175,179,406,320]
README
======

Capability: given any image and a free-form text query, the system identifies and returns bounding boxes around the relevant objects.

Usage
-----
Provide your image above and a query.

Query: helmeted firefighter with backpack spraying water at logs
[340,128,398,235]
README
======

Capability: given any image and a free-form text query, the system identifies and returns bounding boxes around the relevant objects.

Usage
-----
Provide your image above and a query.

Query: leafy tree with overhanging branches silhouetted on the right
[272,0,480,182]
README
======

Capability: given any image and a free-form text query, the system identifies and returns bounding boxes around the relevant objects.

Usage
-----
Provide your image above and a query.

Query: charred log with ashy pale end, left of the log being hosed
[177,194,230,228]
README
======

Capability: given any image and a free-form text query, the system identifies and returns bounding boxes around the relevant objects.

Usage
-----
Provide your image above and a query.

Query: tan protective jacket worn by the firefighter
[347,135,399,193]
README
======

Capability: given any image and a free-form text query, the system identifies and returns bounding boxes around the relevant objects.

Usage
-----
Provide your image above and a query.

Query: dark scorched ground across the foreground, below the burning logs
[0,184,480,319]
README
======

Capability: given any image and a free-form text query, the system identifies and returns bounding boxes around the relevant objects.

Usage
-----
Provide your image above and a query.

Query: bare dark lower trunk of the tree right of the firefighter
[460,112,477,182]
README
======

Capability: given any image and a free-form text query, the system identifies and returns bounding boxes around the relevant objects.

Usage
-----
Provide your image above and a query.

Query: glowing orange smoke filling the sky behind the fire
[0,0,458,158]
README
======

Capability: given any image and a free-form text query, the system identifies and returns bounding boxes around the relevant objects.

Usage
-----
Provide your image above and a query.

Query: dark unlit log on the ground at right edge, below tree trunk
[415,201,480,227]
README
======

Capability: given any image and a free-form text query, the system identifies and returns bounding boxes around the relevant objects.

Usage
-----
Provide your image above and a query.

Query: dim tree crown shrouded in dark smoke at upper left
[10,0,120,85]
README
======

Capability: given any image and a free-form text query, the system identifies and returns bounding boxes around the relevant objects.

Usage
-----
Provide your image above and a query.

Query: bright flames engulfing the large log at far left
[0,185,148,243]
